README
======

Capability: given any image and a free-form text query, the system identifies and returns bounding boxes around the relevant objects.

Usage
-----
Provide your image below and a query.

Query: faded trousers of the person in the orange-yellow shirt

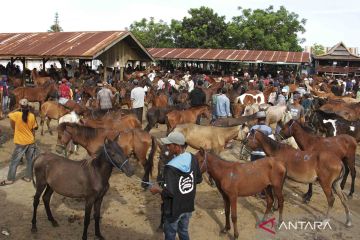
[7,144,35,181]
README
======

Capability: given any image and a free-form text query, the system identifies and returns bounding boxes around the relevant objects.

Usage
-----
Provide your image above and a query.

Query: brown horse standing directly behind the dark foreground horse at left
[57,123,157,188]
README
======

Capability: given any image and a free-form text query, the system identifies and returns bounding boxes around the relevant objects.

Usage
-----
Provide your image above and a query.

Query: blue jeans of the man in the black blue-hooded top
[164,212,191,240]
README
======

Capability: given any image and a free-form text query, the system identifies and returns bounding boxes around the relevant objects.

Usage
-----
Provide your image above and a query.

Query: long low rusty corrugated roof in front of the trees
[147,48,310,64]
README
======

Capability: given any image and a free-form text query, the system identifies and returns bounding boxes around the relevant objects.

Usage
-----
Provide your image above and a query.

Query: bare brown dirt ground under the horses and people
[0,114,360,240]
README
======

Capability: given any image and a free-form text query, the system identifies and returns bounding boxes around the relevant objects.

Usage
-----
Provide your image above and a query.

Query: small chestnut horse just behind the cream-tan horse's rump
[165,105,211,133]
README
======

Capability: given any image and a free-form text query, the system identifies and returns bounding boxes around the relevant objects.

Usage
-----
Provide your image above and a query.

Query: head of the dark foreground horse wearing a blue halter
[103,135,135,177]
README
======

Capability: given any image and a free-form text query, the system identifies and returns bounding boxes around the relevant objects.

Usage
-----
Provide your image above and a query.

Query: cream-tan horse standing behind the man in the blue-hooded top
[173,123,249,154]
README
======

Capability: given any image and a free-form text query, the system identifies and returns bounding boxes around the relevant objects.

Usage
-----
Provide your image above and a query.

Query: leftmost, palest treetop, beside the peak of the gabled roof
[129,17,174,48]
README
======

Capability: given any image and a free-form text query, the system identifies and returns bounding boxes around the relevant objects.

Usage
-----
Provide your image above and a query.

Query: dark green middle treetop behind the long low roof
[171,6,228,48]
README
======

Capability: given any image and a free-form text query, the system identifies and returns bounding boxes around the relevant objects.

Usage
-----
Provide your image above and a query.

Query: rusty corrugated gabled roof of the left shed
[0,31,151,59]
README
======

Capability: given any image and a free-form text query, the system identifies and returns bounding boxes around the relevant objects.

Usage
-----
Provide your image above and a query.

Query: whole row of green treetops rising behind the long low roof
[129,6,306,51]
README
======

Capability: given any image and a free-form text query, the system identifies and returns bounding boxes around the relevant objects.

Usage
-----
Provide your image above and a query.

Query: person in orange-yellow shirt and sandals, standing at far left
[0,99,37,186]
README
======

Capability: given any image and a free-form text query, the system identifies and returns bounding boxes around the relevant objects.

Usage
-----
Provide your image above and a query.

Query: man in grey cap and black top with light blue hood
[150,132,202,240]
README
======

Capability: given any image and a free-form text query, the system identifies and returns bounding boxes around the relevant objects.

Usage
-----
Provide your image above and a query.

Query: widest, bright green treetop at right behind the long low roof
[227,6,306,51]
